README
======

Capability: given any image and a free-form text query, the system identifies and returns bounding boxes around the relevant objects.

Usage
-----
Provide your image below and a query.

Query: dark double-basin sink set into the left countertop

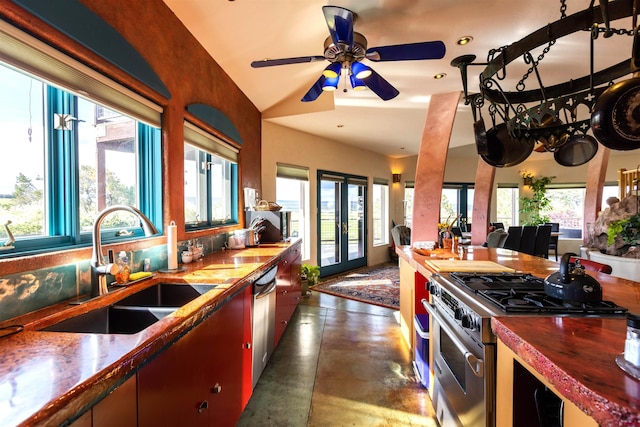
[41,283,216,334]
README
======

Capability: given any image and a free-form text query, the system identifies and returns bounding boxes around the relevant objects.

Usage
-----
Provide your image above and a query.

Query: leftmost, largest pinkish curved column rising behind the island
[411,92,461,242]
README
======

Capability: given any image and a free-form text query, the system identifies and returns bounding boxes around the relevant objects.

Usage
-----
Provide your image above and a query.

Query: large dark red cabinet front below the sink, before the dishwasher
[138,287,251,426]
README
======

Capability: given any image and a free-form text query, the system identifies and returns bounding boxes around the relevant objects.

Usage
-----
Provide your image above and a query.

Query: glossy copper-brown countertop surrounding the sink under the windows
[0,240,300,427]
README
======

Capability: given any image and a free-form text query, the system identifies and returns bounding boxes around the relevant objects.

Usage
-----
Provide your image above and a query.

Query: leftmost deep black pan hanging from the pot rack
[481,123,534,168]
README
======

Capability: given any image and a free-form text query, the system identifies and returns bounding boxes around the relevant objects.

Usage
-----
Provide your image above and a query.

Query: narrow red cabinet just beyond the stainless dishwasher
[274,246,302,345]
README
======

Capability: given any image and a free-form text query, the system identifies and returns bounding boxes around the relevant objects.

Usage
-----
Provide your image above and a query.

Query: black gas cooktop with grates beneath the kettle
[449,273,627,315]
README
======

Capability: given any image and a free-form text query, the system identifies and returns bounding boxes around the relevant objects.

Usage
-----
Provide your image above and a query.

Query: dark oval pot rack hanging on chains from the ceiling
[451,0,636,160]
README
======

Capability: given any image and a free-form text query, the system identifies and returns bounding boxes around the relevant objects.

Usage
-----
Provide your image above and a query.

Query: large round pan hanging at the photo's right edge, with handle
[591,4,640,150]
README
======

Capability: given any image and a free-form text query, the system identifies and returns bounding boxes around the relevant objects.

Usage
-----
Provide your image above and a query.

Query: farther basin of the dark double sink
[114,283,217,309]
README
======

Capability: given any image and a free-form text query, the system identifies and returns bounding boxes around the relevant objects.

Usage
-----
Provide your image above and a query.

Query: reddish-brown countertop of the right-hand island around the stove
[396,247,640,426]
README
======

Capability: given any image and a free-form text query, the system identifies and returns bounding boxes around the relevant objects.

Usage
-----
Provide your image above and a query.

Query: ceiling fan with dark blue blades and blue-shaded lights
[251,6,445,102]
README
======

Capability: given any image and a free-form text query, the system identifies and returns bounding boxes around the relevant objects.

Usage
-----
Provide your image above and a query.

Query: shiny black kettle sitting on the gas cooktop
[544,252,602,303]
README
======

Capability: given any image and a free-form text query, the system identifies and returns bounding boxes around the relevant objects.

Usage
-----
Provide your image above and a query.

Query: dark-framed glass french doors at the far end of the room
[318,171,367,277]
